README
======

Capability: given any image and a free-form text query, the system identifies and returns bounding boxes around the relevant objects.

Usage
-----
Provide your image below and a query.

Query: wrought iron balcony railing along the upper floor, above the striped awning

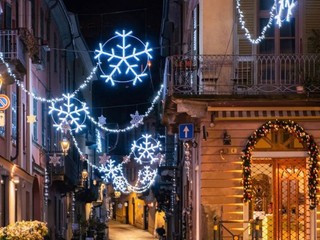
[164,55,320,95]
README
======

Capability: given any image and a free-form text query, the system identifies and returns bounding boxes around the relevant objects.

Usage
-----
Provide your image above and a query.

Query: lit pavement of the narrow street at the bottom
[109,221,157,240]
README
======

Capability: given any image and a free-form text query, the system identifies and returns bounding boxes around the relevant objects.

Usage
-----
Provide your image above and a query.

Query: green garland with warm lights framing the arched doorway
[241,120,319,209]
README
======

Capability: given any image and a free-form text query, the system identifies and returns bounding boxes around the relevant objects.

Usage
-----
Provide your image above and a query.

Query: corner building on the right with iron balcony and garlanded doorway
[161,0,320,239]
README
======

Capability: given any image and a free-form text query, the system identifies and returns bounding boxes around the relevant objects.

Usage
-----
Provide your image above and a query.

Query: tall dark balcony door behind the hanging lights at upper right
[257,0,299,88]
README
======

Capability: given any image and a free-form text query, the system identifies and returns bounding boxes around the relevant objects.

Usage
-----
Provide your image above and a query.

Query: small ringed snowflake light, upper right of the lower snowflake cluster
[131,134,161,164]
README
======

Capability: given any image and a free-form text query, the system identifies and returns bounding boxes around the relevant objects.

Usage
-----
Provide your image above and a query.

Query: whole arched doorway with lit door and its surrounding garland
[242,120,319,240]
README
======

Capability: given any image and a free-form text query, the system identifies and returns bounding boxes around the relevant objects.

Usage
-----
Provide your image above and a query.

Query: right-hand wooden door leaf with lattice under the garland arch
[273,159,310,240]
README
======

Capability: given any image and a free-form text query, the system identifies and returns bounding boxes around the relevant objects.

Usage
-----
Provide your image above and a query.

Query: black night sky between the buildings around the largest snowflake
[64,0,162,127]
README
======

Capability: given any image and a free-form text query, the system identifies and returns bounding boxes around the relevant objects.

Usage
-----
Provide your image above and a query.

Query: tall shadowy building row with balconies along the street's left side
[0,0,93,239]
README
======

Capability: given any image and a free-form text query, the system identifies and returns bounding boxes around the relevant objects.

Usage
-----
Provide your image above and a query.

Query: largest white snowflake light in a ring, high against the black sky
[94,30,152,86]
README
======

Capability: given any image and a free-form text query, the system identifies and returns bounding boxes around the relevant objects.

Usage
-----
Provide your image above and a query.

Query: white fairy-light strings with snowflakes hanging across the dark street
[0,31,163,193]
